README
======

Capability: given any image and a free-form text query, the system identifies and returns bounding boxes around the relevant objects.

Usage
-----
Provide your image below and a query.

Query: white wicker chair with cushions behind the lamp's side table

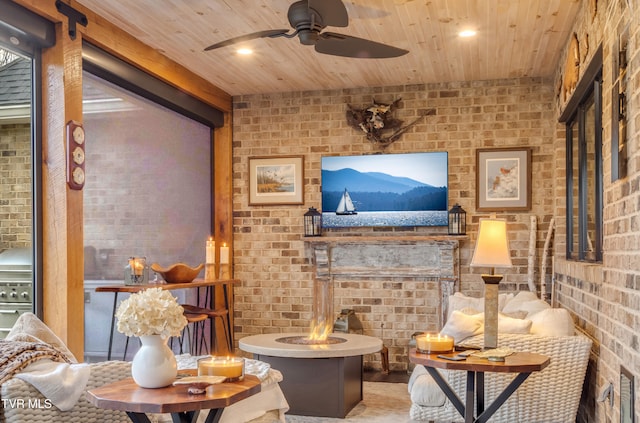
[410,334,591,423]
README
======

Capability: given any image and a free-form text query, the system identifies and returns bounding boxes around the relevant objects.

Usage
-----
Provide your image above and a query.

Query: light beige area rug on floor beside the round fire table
[286,382,412,423]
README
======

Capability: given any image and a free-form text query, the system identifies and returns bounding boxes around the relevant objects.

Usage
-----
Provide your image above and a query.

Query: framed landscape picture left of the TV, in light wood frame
[249,156,304,206]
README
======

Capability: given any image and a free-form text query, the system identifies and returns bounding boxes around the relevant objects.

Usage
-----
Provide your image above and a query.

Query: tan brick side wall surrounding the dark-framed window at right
[555,1,640,422]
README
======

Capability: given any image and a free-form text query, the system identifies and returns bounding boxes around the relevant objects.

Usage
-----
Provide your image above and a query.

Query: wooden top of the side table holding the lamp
[409,348,550,373]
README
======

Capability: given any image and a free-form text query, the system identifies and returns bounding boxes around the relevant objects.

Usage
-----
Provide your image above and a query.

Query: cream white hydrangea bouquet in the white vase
[116,288,187,338]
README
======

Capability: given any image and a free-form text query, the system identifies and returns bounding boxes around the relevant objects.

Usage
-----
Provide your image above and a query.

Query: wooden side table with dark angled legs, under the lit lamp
[409,348,551,423]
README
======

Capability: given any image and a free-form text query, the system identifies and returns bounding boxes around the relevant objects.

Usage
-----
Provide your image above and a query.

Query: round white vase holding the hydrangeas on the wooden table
[131,335,178,388]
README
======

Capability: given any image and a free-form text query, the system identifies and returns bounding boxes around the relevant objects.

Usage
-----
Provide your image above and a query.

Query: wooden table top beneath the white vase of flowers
[87,370,260,413]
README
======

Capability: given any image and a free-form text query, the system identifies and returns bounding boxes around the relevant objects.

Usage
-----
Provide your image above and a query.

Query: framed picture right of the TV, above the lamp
[476,147,531,211]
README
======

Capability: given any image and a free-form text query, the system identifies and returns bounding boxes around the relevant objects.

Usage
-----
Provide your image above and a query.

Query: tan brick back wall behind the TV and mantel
[233,78,559,368]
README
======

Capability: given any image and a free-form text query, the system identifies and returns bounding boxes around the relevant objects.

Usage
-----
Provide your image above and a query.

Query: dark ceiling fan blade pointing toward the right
[315,32,409,59]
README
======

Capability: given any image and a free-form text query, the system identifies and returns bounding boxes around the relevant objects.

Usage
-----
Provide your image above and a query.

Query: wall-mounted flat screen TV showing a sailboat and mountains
[321,152,448,228]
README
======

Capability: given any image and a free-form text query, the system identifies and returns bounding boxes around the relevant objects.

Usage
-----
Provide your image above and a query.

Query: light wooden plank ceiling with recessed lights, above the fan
[78,0,580,95]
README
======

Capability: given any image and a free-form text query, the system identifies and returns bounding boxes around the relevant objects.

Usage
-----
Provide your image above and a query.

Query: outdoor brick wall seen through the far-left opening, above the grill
[0,123,33,251]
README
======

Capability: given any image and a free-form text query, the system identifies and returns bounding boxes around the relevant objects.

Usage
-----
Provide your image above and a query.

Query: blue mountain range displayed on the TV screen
[322,168,447,212]
